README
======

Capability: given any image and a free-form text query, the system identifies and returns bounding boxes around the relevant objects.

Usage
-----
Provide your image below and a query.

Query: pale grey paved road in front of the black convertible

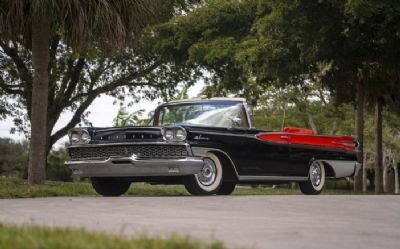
[0,196,400,249]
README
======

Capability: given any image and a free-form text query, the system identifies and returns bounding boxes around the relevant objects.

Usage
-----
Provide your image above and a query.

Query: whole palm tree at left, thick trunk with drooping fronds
[0,0,162,184]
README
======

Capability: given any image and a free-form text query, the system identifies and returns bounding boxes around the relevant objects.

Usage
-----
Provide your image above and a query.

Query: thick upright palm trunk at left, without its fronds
[28,15,50,184]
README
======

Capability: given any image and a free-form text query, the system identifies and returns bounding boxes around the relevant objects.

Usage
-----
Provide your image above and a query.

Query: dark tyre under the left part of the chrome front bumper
[91,177,131,196]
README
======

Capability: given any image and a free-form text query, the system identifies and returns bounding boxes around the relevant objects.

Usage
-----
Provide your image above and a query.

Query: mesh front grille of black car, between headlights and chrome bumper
[68,144,188,160]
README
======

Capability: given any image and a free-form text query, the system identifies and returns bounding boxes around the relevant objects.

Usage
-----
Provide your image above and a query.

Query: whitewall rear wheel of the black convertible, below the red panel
[299,161,325,195]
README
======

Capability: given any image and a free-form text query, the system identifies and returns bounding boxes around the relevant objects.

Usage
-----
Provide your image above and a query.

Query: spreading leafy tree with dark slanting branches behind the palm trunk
[0,39,195,151]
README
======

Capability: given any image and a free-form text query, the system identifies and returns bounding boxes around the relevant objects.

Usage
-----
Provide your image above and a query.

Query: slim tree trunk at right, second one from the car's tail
[375,99,383,193]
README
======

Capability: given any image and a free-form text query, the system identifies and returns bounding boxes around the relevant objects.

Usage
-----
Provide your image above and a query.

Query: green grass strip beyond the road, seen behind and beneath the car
[0,177,352,199]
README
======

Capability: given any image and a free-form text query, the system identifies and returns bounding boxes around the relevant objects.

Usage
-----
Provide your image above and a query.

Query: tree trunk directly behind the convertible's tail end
[354,79,364,193]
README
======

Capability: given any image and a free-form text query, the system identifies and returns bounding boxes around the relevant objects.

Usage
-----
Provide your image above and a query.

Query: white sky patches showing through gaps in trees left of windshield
[0,81,204,149]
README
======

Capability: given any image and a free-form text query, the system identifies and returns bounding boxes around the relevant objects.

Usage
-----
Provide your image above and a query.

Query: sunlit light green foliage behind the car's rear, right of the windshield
[255,84,354,135]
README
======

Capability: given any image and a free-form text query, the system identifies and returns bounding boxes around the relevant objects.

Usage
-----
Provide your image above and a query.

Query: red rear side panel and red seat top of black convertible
[257,127,357,151]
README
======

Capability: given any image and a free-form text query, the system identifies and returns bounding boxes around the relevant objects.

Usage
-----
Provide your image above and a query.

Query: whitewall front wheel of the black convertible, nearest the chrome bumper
[184,153,223,195]
